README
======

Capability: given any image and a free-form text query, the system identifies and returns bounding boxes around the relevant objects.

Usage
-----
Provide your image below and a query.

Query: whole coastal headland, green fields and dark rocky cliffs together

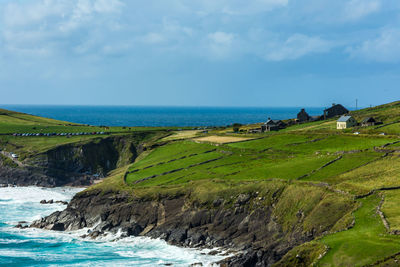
[0,102,400,266]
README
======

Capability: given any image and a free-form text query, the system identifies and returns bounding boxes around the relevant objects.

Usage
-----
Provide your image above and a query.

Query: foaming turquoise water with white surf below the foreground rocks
[0,187,222,266]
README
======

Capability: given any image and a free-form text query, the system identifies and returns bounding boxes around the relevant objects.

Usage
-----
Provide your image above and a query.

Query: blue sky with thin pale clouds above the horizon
[0,0,400,107]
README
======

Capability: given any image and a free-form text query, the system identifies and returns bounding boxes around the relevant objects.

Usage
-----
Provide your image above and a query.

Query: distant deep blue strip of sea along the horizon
[0,105,324,126]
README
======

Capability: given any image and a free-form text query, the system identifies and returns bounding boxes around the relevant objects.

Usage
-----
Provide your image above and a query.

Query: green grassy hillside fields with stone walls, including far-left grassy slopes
[0,102,400,266]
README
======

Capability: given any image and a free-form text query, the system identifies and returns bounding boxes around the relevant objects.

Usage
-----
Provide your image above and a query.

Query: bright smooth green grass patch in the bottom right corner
[318,195,400,266]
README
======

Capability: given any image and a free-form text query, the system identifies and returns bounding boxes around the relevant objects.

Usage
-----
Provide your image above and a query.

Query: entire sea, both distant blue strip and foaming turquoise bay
[0,105,323,266]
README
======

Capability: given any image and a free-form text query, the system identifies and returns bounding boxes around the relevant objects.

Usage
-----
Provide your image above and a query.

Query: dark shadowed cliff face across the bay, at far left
[0,136,141,187]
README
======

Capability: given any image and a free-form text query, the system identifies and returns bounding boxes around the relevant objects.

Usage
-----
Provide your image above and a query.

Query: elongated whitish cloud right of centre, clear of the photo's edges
[264,34,333,61]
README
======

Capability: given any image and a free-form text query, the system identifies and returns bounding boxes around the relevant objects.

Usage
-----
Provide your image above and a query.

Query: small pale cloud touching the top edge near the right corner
[344,0,381,20]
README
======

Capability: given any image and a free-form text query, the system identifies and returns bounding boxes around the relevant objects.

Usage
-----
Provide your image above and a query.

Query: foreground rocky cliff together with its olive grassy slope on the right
[32,182,355,266]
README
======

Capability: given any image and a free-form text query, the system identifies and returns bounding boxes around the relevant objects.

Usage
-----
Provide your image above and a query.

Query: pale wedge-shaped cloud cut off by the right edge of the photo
[347,29,400,63]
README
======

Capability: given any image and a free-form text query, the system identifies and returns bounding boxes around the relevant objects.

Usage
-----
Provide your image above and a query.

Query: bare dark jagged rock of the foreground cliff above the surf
[31,186,354,266]
